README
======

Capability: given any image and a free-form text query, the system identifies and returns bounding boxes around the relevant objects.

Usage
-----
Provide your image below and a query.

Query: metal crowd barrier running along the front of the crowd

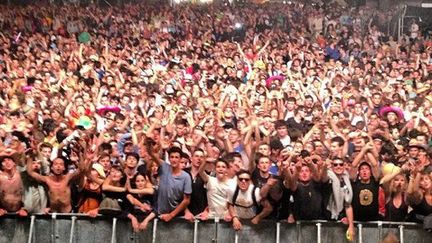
[0,213,432,243]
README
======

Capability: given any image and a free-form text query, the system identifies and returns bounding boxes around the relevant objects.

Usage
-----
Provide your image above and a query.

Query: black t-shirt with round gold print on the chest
[351,177,379,221]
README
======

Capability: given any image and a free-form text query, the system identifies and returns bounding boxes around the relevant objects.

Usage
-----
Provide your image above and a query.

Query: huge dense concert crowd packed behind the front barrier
[0,1,432,239]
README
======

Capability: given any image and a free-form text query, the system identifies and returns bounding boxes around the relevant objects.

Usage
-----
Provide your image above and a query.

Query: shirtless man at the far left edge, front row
[0,156,27,217]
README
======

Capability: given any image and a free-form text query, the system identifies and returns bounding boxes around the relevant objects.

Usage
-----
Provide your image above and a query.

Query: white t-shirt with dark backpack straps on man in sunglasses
[228,184,261,219]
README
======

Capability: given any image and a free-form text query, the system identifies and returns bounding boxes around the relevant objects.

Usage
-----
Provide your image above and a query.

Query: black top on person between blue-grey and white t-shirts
[185,168,208,215]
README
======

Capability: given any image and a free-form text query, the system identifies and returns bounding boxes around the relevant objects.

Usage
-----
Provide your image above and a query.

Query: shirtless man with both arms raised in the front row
[27,154,84,213]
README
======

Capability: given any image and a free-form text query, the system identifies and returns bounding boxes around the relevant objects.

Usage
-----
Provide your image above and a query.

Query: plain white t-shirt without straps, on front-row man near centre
[206,176,237,218]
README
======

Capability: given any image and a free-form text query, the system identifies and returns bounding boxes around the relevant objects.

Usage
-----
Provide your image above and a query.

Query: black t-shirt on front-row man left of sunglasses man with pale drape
[293,181,323,220]
